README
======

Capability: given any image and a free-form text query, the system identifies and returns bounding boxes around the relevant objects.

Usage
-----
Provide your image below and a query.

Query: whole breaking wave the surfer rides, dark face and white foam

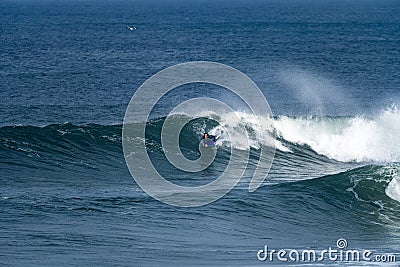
[0,107,400,204]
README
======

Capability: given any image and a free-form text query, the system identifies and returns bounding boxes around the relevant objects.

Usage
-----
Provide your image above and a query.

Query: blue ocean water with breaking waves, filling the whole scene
[0,0,400,266]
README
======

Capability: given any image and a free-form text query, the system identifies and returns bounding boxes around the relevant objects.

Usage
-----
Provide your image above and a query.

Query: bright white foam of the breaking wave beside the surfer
[181,106,400,163]
